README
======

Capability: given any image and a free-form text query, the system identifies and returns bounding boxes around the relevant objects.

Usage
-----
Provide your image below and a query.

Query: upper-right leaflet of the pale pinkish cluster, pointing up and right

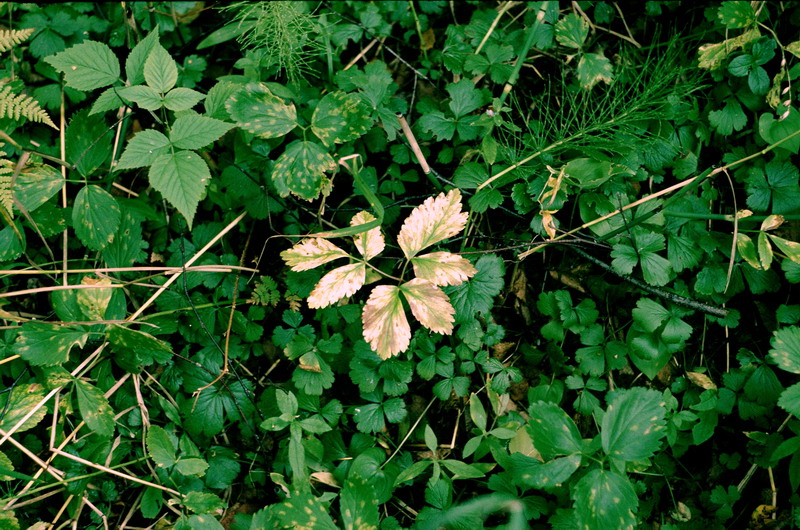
[397,189,467,258]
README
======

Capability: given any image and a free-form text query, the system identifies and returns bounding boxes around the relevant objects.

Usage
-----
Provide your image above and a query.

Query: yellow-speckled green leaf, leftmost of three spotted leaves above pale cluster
[225,83,297,138]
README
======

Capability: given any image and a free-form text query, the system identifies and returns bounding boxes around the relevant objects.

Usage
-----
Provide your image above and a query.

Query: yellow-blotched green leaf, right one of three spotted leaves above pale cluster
[311,91,372,147]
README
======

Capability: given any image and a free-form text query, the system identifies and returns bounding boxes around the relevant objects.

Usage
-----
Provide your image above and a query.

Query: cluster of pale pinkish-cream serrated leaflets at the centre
[281,189,476,359]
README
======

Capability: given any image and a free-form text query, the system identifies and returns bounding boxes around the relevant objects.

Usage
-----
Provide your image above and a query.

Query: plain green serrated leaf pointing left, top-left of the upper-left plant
[45,41,119,90]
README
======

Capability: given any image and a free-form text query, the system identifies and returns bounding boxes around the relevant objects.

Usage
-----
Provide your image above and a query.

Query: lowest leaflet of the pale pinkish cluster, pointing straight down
[361,285,411,359]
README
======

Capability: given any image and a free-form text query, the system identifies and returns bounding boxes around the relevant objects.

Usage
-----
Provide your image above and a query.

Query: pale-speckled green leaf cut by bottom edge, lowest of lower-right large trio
[572,469,639,530]
